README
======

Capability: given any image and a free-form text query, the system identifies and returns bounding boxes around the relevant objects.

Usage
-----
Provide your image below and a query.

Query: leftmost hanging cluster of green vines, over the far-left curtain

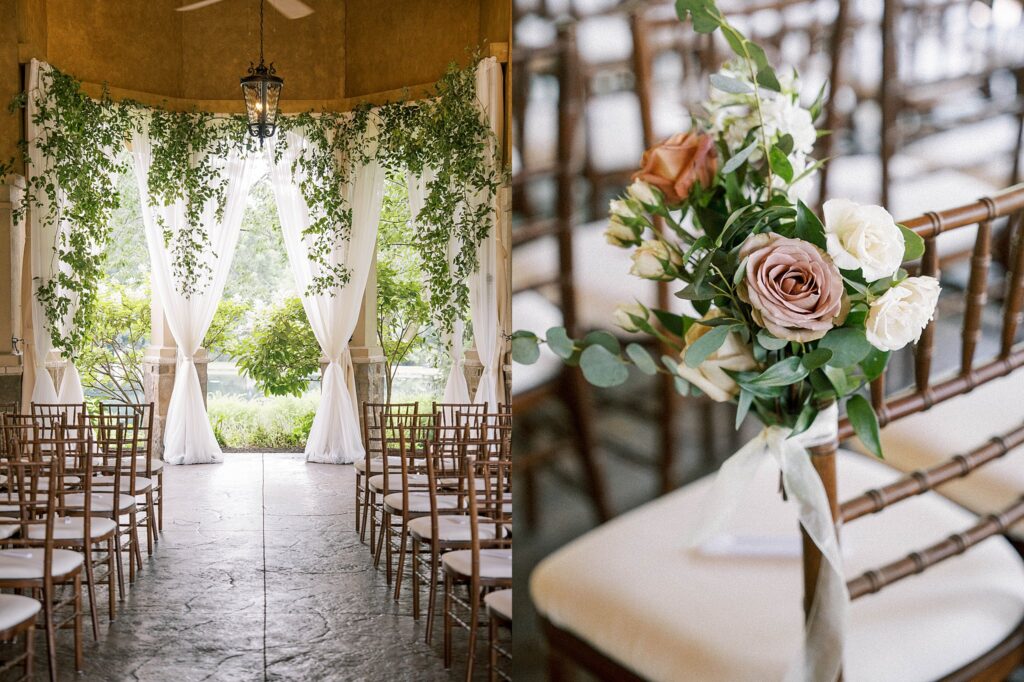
[0,65,131,357]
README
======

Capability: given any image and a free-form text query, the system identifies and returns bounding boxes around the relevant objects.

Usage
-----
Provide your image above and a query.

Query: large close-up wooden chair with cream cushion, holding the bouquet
[530,186,1024,680]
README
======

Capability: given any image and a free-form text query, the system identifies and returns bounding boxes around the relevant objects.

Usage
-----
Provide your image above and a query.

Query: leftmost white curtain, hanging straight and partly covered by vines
[26,59,85,402]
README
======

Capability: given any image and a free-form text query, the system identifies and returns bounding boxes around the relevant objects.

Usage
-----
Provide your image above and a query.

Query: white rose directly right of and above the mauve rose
[821,199,903,282]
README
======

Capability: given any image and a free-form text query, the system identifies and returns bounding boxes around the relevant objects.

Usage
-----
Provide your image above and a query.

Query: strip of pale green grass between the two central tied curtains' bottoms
[208,394,318,450]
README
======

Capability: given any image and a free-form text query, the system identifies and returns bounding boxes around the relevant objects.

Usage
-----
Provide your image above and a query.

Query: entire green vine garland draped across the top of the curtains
[0,54,507,357]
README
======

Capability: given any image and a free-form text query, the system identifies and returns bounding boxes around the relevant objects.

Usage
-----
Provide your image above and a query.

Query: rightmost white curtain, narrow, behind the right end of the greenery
[469,57,505,403]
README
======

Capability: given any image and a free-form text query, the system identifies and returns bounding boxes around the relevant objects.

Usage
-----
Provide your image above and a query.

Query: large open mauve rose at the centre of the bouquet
[739,232,850,342]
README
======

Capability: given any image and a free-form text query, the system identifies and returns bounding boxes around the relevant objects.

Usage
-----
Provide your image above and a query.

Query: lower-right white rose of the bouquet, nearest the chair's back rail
[865,276,939,350]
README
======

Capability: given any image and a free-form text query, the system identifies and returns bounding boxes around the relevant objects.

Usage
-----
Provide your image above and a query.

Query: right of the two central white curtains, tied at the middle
[268,117,385,464]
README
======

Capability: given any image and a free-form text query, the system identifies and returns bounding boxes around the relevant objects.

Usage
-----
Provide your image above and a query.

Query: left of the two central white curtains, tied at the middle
[132,125,255,464]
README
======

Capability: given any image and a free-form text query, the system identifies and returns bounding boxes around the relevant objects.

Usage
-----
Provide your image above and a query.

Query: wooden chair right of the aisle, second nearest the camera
[441,455,512,682]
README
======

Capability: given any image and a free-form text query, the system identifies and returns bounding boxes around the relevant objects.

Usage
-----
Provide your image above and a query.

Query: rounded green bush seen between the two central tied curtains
[232,298,321,397]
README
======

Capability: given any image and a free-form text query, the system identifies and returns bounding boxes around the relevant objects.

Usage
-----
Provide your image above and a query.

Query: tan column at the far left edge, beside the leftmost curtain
[0,175,25,402]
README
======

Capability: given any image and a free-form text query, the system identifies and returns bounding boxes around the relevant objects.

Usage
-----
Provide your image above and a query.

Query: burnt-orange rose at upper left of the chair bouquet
[633,132,718,206]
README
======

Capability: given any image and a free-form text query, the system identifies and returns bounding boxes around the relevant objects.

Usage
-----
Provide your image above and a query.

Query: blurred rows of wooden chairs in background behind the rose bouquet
[513,0,1024,679]
